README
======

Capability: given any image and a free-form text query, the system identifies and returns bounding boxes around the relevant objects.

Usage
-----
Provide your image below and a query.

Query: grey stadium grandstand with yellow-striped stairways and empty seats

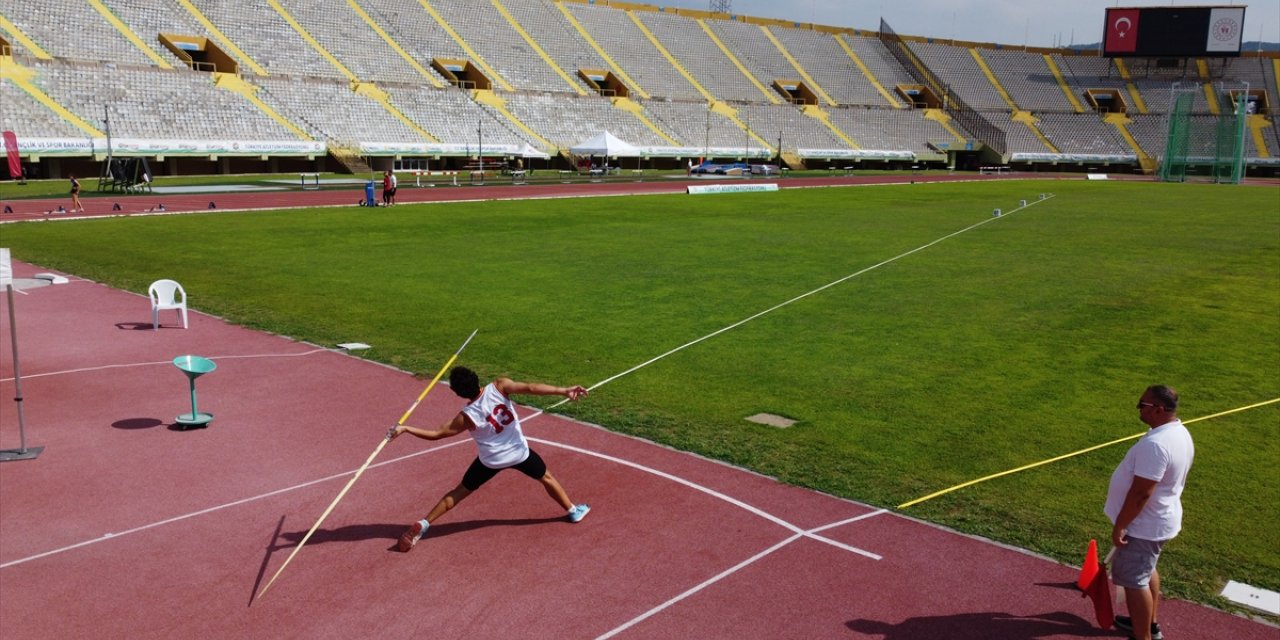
[0,0,1280,178]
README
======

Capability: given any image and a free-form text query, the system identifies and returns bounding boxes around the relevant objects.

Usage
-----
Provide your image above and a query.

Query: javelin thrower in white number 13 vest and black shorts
[390,366,591,552]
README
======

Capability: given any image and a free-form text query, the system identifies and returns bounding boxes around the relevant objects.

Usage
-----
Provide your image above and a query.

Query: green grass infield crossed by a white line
[0,180,1280,607]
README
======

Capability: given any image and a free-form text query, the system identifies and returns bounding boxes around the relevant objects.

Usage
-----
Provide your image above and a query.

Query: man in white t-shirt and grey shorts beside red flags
[1103,384,1196,640]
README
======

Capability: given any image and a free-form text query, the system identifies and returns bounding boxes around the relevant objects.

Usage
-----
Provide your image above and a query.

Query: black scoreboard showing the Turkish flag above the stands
[1102,6,1245,58]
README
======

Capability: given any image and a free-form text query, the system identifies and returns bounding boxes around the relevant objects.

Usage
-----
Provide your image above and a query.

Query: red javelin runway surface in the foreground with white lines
[0,231,1276,640]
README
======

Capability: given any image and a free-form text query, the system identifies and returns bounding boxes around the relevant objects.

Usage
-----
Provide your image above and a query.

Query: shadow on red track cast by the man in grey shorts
[845,612,1115,640]
